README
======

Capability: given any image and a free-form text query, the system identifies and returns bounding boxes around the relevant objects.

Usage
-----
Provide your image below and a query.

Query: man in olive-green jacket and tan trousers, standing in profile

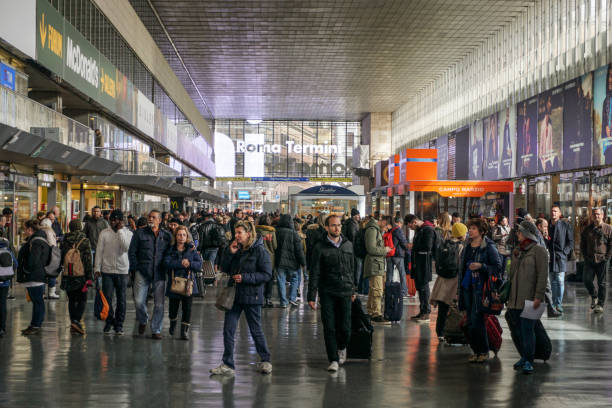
[363,217,391,323]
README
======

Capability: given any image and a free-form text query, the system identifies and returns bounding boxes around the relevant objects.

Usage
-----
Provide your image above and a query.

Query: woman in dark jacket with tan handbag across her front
[164,225,202,340]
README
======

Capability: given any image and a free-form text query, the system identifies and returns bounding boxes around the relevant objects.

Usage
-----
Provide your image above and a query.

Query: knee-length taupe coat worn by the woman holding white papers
[508,242,548,310]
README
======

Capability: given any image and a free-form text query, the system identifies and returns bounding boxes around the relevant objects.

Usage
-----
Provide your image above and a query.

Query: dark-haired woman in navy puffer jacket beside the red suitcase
[459,218,502,363]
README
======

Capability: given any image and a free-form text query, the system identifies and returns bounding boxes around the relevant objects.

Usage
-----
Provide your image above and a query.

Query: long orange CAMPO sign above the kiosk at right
[409,180,514,197]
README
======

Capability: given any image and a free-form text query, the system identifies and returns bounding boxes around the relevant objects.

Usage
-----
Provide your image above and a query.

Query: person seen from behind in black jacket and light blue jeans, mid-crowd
[274,214,306,308]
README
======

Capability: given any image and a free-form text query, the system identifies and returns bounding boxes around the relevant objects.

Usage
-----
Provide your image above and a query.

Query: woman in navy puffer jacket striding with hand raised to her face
[210,221,272,375]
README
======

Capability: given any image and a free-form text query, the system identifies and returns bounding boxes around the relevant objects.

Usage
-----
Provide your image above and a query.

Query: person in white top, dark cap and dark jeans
[94,210,132,336]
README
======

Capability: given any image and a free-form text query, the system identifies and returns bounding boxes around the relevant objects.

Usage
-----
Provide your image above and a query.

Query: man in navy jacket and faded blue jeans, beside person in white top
[128,210,172,340]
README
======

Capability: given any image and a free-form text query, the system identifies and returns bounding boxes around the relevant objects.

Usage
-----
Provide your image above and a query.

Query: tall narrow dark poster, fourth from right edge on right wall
[516,97,538,176]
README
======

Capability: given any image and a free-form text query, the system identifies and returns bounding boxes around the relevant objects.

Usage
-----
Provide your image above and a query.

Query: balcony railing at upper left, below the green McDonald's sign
[0,86,95,154]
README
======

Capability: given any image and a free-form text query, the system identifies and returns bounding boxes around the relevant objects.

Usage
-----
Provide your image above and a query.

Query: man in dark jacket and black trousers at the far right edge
[580,208,612,313]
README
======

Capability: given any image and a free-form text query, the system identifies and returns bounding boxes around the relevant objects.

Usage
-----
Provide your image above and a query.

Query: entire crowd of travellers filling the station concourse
[0,206,612,375]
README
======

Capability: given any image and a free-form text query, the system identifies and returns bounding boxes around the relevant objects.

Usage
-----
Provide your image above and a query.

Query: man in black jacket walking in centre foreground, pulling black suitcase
[308,215,356,371]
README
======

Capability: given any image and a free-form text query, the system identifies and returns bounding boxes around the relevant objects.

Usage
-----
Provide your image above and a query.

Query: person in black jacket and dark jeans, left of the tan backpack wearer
[17,220,51,336]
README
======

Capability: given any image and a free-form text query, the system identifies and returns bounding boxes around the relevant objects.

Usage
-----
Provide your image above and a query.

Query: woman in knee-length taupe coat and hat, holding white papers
[507,221,548,374]
